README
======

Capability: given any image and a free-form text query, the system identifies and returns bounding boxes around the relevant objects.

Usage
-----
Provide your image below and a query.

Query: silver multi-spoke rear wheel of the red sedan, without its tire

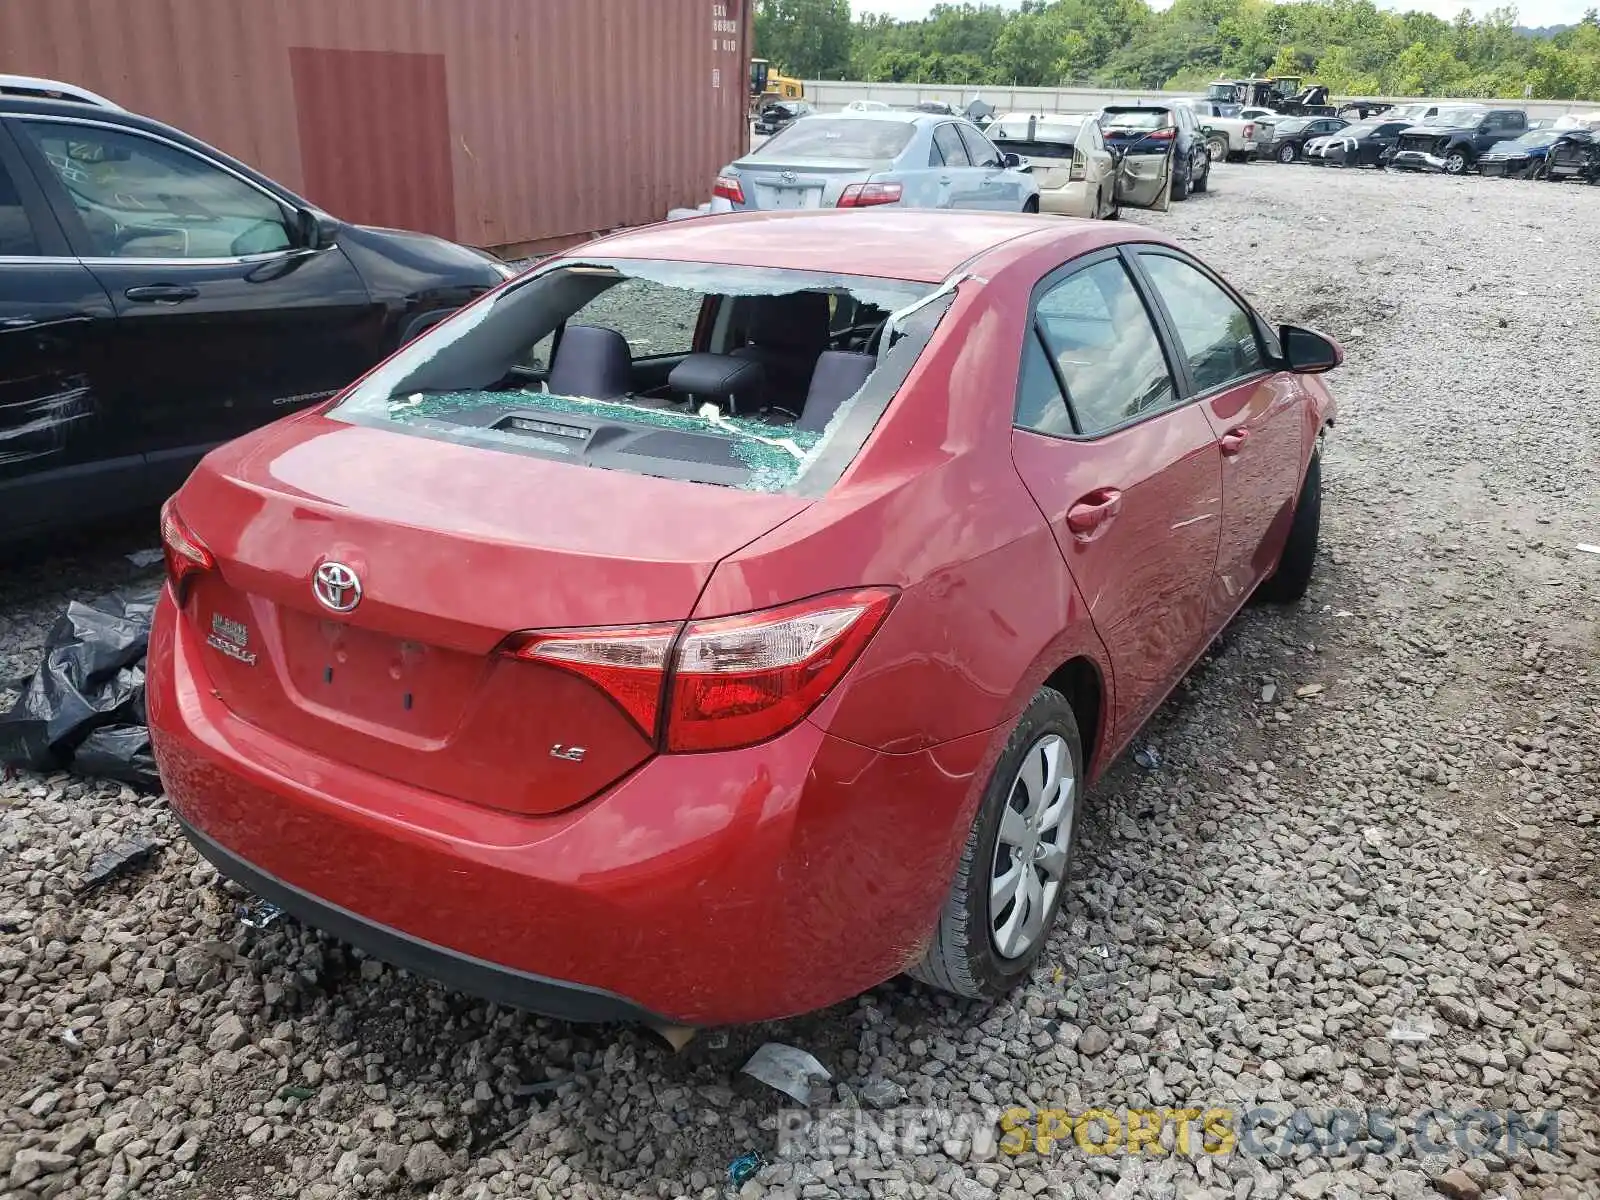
[989,733,1077,958]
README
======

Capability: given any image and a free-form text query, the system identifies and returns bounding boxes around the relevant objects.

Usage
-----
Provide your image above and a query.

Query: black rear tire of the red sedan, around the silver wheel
[907,688,1083,1000]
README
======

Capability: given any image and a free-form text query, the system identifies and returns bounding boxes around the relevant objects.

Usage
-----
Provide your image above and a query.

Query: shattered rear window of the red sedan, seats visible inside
[328,259,952,494]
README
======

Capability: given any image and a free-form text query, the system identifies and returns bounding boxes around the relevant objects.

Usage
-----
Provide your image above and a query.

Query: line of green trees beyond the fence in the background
[755,0,1600,99]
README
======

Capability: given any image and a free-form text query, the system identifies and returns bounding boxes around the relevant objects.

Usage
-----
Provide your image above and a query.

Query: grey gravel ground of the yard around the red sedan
[0,165,1600,1200]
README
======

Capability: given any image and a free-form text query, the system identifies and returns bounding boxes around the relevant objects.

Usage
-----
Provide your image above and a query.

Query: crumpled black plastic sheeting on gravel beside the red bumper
[0,589,162,790]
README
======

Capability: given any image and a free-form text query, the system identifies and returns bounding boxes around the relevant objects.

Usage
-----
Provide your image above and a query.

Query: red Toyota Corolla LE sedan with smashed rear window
[149,210,1341,1024]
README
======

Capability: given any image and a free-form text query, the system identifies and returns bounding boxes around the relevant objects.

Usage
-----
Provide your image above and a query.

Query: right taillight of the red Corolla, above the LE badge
[506,587,896,752]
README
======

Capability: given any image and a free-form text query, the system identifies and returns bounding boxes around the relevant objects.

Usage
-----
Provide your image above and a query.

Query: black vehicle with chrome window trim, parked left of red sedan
[0,75,512,541]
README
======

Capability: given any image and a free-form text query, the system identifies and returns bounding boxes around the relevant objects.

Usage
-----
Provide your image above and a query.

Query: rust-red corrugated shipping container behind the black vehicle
[0,0,754,250]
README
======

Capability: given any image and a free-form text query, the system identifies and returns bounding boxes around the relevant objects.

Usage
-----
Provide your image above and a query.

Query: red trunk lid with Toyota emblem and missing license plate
[178,416,808,813]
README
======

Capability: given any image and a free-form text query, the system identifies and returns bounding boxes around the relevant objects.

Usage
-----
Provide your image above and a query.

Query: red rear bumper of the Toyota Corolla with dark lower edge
[147,592,1003,1026]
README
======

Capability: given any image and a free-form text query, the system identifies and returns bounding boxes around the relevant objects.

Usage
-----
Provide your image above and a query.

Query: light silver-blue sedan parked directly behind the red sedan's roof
[712,112,1038,213]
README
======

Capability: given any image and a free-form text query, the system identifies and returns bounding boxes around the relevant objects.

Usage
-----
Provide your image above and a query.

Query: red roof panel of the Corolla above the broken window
[566,208,1113,283]
